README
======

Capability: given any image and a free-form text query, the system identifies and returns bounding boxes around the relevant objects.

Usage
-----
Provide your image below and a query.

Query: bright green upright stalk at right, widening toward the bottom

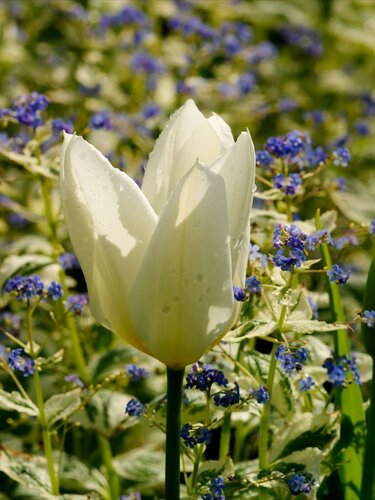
[315,210,366,500]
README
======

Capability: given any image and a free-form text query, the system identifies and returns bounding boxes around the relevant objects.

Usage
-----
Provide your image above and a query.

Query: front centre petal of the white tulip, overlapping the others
[129,162,233,368]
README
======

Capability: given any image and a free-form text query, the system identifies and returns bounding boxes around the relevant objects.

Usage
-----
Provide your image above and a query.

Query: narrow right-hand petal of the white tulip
[211,132,255,286]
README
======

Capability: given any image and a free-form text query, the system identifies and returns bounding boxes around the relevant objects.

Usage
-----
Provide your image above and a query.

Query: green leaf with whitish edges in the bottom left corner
[0,450,56,500]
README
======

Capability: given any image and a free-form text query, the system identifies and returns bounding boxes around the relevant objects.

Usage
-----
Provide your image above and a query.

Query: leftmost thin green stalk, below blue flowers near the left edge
[27,307,59,495]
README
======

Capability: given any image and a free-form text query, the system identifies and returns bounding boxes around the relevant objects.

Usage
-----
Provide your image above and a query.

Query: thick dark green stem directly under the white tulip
[165,367,184,500]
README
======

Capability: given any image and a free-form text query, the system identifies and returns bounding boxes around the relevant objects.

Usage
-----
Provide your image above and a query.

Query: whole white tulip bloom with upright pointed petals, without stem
[61,100,255,370]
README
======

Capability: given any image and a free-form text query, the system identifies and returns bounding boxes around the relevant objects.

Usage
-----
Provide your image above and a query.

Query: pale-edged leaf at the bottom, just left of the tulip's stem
[113,448,165,492]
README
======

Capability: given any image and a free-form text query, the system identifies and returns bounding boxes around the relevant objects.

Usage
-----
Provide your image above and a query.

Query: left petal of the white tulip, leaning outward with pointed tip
[61,134,157,352]
